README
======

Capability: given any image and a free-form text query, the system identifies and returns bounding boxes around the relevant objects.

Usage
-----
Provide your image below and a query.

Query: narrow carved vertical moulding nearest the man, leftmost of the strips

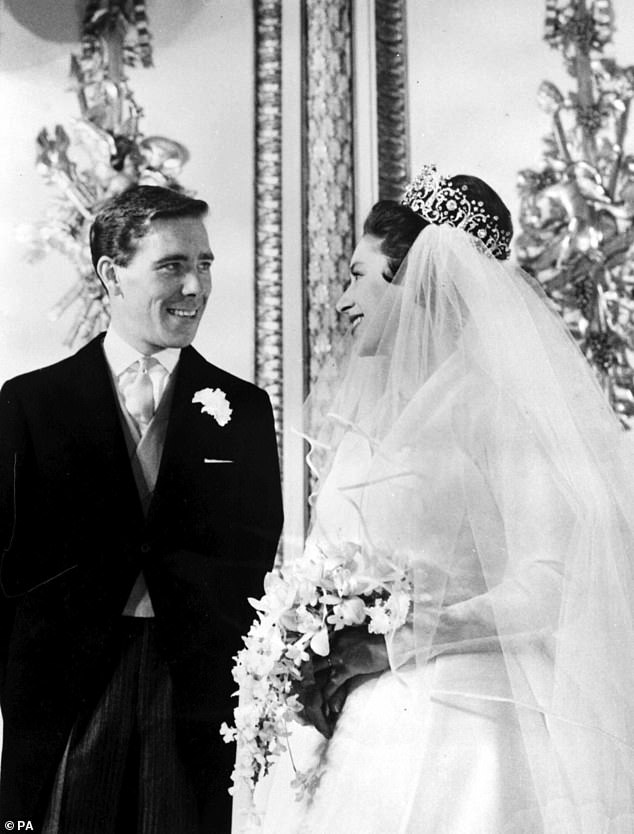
[255,0,284,458]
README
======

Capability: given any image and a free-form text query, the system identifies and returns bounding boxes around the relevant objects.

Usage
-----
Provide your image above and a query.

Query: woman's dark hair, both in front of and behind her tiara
[363,174,513,280]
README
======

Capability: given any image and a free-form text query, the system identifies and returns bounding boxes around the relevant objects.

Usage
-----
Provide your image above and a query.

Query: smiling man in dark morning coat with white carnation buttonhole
[0,186,282,834]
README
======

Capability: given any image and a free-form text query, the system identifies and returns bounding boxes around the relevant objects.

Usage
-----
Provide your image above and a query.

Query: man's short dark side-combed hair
[90,185,209,270]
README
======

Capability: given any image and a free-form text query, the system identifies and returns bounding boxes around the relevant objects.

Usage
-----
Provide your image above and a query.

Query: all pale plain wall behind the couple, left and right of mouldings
[0,0,634,381]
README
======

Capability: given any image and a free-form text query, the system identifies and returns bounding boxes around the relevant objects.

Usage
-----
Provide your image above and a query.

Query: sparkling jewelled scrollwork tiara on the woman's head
[401,165,511,260]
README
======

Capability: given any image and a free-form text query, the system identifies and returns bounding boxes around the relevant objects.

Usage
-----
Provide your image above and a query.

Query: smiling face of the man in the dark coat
[103,217,213,355]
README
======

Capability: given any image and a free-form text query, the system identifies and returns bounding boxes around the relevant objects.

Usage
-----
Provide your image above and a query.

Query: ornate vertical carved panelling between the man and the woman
[253,0,409,539]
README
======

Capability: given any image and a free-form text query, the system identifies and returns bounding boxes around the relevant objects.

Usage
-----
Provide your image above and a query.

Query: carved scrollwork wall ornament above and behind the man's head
[18,0,189,348]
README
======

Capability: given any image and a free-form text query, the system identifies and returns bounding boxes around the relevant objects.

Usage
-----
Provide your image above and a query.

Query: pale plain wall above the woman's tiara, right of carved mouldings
[407,0,634,231]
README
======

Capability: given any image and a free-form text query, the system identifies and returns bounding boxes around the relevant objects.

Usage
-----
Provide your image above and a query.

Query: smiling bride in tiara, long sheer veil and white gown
[242,168,634,834]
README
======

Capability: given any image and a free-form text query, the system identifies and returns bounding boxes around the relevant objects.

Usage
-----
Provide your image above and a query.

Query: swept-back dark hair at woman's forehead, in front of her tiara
[363,200,429,281]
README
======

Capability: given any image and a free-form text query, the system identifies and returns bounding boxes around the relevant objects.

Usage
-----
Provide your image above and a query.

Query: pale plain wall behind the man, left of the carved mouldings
[0,0,253,381]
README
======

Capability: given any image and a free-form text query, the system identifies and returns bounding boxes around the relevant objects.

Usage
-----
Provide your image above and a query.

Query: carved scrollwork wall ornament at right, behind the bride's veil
[516,0,634,428]
